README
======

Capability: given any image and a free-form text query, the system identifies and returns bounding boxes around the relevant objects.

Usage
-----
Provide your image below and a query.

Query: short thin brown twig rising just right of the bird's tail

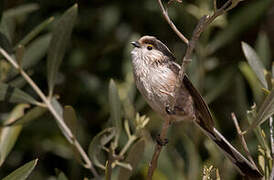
[231,113,257,167]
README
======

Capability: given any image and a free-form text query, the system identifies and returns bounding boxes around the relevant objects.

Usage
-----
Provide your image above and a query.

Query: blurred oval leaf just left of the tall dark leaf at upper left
[22,34,51,68]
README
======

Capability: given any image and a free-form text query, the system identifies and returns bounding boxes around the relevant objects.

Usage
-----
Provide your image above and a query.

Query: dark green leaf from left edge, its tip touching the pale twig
[0,83,37,104]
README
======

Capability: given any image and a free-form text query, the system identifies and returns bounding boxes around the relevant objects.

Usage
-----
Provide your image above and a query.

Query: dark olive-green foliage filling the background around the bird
[0,0,274,180]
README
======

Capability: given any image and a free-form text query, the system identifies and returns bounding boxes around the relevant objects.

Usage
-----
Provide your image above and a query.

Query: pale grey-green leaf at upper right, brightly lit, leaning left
[242,42,267,88]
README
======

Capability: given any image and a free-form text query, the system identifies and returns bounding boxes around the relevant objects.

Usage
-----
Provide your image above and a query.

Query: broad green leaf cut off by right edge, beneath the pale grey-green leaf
[248,89,274,130]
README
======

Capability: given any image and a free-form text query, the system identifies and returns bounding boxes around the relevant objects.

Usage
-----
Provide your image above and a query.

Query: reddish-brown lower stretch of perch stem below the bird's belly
[147,118,171,180]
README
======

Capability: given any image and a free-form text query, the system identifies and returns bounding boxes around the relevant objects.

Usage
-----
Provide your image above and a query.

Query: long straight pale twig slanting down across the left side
[0,48,98,177]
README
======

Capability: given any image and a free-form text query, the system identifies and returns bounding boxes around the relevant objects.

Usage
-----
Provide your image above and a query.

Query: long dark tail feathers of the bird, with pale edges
[196,123,263,179]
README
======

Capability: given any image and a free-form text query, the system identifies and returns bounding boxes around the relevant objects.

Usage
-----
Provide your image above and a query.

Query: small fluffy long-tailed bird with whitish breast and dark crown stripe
[131,35,262,179]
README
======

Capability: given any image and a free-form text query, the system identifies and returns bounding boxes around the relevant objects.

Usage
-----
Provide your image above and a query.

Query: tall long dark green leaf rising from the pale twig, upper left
[47,4,78,97]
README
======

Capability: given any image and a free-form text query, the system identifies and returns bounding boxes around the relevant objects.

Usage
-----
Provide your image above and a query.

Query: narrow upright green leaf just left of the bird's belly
[108,79,122,146]
